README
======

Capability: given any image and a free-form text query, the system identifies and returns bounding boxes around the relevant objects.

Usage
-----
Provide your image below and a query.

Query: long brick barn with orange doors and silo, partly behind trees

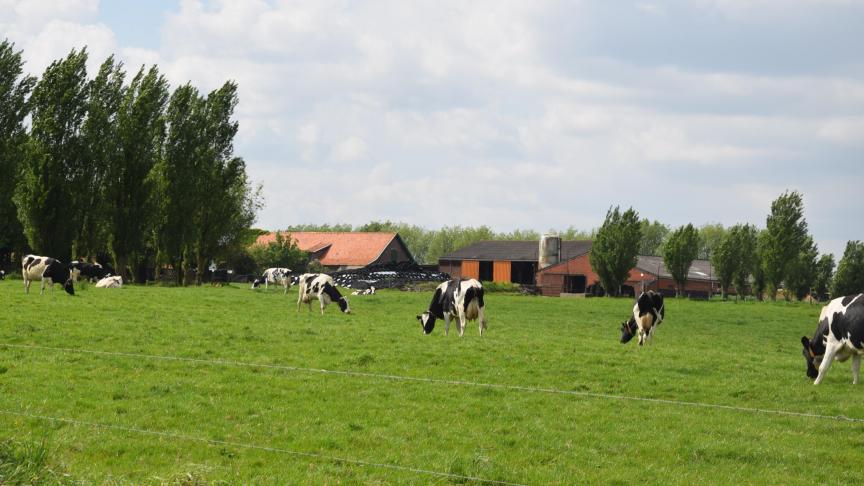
[438,237,719,297]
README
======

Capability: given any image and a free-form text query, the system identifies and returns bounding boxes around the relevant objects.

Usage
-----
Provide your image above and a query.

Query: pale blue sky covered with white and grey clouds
[0,0,864,257]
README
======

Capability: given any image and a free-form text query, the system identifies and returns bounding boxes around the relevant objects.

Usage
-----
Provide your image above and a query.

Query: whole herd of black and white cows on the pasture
[10,255,864,385]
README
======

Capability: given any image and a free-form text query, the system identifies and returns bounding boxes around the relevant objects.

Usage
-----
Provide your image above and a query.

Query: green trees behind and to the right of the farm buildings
[250,191,864,300]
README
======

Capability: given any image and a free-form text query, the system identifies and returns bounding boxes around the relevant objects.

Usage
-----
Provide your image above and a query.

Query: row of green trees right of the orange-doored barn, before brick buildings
[590,191,864,300]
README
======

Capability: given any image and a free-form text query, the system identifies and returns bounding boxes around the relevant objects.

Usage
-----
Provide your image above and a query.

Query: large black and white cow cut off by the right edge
[801,294,864,385]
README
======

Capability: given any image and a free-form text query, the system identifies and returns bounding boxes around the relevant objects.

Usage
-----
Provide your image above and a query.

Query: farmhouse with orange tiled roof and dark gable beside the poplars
[255,231,414,270]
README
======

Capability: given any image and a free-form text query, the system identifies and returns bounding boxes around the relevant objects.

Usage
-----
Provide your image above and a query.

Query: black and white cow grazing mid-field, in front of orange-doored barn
[417,278,486,337]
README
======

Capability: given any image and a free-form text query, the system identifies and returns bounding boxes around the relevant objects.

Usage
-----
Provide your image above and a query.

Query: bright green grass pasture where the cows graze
[0,280,864,484]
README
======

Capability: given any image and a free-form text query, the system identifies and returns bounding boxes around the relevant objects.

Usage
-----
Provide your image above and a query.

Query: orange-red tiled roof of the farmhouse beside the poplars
[255,231,396,266]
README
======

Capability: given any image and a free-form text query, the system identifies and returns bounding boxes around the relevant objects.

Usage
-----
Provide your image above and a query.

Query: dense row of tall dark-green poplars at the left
[0,40,260,283]
